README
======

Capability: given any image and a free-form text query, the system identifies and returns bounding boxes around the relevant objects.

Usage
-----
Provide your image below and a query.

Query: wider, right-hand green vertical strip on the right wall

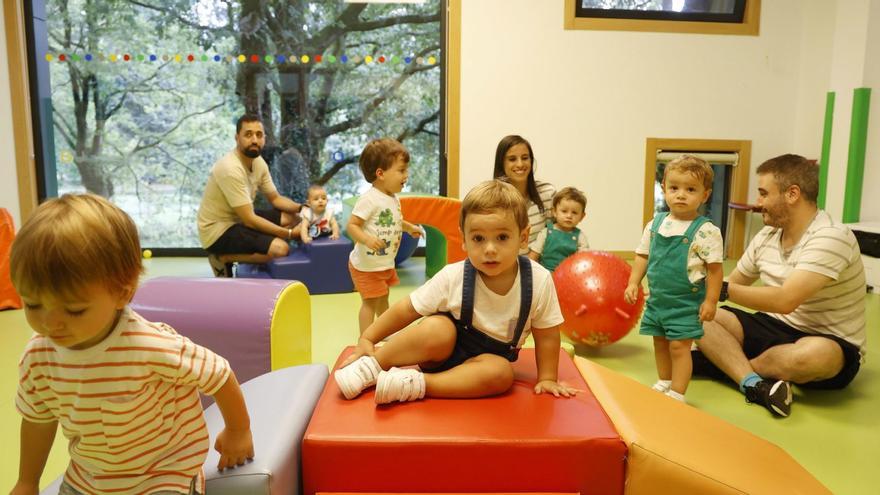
[842,88,871,223]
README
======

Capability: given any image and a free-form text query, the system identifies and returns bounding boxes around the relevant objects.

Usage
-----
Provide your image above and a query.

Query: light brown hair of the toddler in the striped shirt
[10,194,143,297]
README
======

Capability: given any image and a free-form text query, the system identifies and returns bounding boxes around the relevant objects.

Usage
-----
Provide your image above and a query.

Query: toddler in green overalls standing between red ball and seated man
[624,155,724,402]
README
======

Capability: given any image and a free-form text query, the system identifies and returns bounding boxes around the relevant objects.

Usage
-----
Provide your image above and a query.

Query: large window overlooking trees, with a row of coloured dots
[26,0,445,252]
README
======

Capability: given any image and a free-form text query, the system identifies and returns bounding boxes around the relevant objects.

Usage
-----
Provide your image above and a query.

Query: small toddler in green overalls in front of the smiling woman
[529,187,590,272]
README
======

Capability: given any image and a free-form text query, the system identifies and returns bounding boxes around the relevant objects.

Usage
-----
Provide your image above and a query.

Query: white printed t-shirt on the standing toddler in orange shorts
[349,187,403,272]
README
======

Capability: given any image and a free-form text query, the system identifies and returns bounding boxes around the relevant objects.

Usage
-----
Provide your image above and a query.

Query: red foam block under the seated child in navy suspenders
[302,348,626,494]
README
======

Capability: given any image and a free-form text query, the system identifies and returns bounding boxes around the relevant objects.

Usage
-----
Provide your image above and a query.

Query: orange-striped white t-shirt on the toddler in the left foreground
[15,308,230,494]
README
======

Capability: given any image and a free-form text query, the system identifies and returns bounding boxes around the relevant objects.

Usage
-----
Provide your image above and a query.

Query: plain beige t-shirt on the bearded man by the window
[198,150,277,248]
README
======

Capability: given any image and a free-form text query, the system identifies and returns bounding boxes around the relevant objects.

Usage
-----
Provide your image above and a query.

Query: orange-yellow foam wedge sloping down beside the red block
[575,357,831,495]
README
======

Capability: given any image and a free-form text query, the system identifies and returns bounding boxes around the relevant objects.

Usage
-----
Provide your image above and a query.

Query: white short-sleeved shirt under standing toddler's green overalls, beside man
[636,215,724,283]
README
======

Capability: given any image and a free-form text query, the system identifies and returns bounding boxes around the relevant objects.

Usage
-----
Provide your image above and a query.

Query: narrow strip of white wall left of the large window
[0,5,21,230]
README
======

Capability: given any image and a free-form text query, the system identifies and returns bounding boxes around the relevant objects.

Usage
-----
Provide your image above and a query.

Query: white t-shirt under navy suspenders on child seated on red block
[409,260,563,347]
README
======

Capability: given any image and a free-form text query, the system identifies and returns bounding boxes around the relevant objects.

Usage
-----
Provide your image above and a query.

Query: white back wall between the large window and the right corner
[461,0,833,250]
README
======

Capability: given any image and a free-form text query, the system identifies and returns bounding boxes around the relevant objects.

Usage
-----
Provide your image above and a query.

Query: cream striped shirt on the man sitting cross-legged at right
[736,210,866,361]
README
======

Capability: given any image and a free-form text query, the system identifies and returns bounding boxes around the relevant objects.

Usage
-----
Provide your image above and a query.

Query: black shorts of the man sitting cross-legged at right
[724,306,861,389]
